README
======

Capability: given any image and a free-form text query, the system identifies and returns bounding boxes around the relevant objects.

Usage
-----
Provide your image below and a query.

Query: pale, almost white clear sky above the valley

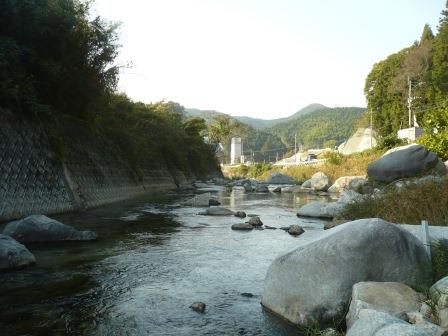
[94,0,445,119]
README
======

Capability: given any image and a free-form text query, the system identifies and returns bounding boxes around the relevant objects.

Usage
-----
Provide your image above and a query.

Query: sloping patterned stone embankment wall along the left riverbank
[0,111,182,221]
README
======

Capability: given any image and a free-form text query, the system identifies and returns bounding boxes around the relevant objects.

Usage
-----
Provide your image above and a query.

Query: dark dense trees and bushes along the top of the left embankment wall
[0,0,217,175]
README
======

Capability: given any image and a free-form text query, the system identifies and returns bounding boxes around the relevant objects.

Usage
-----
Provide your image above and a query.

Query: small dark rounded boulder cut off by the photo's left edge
[0,234,36,270]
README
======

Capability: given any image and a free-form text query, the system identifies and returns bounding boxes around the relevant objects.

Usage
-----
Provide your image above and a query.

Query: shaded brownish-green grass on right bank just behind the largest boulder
[343,179,448,226]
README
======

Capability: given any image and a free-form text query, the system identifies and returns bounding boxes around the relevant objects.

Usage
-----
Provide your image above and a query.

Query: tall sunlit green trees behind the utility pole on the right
[364,3,448,160]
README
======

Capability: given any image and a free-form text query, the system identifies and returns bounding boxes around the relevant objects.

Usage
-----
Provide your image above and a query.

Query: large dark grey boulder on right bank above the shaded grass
[367,144,440,183]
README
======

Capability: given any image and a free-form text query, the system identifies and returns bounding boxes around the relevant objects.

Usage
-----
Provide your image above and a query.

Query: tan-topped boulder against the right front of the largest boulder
[346,281,421,328]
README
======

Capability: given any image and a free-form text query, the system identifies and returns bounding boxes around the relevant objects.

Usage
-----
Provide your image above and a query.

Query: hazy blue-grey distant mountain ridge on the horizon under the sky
[185,104,327,129]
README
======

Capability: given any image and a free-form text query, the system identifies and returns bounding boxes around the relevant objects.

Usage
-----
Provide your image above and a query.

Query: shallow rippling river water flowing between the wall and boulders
[0,185,332,336]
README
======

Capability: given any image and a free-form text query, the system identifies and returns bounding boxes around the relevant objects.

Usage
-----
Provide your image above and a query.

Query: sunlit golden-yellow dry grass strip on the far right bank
[259,150,383,183]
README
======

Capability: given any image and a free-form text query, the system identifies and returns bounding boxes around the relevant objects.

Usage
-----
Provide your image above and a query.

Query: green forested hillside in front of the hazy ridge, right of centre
[266,107,365,148]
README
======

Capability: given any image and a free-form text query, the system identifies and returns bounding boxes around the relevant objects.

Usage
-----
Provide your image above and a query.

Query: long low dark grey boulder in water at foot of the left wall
[3,215,98,243]
